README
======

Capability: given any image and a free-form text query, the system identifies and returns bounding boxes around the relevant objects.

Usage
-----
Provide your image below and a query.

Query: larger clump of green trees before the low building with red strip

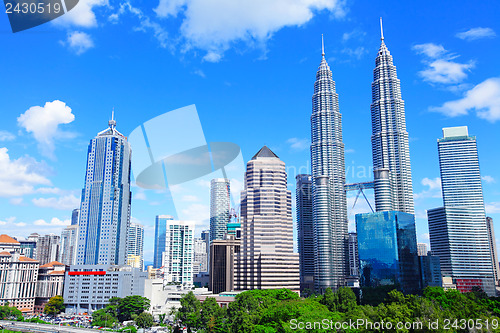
[92,295,150,327]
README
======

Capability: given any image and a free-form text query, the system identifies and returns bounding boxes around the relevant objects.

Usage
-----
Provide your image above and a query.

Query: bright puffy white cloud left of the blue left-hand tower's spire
[17,100,75,158]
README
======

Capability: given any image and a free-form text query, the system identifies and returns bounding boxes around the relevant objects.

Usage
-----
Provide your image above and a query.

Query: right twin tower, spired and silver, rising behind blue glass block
[371,19,414,214]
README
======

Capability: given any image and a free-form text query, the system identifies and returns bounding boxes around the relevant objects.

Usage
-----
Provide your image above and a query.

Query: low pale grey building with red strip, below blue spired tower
[63,265,147,314]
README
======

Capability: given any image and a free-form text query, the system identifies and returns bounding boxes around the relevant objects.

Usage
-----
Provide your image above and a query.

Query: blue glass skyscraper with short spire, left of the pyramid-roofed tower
[76,117,131,265]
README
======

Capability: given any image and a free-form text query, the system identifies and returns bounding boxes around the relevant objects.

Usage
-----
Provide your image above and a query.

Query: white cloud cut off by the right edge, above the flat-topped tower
[430,77,500,123]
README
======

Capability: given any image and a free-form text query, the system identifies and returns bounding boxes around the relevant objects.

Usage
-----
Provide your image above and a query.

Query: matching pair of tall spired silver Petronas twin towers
[311,22,413,292]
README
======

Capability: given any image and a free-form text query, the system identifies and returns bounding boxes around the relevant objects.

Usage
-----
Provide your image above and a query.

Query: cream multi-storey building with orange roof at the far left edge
[0,252,40,313]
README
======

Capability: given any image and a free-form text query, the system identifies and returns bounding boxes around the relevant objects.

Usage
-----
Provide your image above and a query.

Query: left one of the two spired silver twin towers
[311,35,348,292]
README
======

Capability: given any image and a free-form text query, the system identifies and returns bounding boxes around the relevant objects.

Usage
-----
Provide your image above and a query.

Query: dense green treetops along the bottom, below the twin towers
[171,287,500,333]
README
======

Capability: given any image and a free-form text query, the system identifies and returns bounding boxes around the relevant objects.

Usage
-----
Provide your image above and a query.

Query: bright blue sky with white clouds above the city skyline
[0,0,500,261]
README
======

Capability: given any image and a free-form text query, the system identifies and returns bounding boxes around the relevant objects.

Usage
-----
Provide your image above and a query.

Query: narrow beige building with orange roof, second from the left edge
[34,261,66,313]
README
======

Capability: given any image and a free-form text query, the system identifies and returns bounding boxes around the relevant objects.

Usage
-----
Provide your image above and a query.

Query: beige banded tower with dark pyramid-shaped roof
[235,146,300,290]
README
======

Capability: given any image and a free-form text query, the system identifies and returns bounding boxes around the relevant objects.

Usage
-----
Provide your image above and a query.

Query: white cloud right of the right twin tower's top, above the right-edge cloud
[413,43,475,84]
